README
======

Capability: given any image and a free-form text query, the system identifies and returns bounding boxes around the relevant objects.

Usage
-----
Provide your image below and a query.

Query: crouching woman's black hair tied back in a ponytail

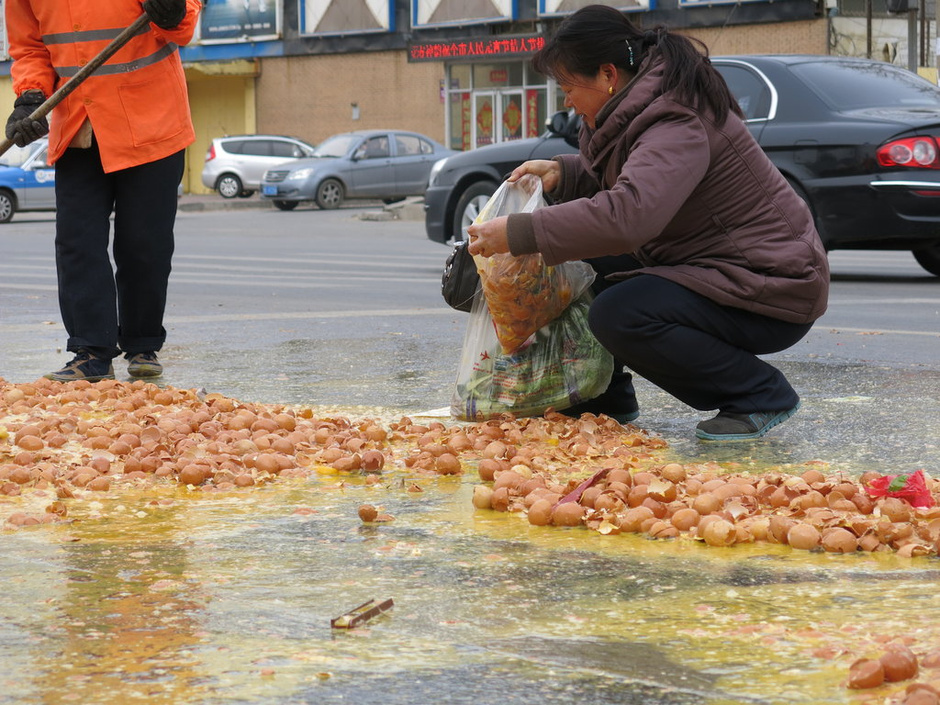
[532,5,742,125]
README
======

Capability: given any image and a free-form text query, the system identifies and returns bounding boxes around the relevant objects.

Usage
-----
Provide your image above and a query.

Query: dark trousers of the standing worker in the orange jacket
[55,143,185,357]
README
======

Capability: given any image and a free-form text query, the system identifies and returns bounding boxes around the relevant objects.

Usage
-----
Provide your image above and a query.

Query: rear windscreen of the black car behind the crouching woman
[791,61,940,110]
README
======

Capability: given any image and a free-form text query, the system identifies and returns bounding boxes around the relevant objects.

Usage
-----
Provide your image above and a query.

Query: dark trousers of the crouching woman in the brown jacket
[588,256,812,414]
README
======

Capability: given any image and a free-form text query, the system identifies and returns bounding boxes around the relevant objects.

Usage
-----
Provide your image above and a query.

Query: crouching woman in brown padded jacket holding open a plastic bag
[469,5,829,440]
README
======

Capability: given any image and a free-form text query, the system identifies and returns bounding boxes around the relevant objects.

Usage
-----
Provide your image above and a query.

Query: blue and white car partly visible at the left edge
[0,138,55,223]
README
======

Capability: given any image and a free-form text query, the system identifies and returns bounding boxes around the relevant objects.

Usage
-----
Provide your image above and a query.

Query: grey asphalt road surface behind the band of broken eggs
[0,196,940,474]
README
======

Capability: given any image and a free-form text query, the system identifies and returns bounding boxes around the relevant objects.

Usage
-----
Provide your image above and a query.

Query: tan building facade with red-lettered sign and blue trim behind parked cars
[0,0,932,193]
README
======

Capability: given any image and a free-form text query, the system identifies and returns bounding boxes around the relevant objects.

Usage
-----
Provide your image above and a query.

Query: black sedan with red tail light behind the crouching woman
[425,55,940,276]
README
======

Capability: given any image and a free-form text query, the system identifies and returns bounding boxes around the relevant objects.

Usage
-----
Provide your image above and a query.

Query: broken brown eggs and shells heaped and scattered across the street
[0,379,940,705]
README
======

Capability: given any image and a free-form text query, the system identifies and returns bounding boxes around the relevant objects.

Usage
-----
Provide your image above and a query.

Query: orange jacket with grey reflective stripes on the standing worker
[5,0,202,172]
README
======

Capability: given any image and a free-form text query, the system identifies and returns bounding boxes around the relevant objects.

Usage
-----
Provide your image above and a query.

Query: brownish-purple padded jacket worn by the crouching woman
[508,57,829,323]
